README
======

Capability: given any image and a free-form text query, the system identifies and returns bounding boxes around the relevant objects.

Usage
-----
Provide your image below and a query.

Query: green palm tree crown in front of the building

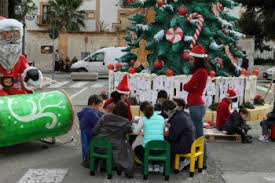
[49,0,86,32]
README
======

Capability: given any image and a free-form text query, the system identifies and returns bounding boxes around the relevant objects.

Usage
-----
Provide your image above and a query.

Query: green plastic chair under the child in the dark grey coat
[90,137,113,179]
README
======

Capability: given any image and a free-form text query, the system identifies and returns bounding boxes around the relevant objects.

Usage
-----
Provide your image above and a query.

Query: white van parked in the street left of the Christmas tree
[71,47,126,74]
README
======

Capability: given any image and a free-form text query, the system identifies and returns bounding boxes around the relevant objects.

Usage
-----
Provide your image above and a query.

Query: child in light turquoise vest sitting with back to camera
[135,102,165,172]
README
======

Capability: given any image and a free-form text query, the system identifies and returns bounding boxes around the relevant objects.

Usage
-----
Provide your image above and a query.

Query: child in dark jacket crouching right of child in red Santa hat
[222,108,252,143]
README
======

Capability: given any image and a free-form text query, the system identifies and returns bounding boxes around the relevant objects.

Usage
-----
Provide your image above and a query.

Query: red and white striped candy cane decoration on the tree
[187,12,204,49]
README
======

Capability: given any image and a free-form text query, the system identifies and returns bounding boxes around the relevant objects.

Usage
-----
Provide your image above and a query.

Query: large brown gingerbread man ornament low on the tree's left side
[131,39,153,69]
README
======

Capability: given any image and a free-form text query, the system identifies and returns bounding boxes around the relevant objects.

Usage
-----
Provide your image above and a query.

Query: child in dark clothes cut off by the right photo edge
[259,105,275,142]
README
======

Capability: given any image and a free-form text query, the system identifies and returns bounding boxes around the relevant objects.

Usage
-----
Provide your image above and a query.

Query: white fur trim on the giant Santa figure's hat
[0,16,23,39]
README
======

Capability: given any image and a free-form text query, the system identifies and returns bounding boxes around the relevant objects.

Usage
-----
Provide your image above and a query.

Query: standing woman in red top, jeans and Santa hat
[183,45,211,169]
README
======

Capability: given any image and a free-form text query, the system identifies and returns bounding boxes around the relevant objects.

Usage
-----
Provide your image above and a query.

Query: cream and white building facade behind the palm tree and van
[26,0,137,70]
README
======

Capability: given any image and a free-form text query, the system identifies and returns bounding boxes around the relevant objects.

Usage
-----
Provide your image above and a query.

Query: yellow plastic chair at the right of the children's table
[174,136,204,177]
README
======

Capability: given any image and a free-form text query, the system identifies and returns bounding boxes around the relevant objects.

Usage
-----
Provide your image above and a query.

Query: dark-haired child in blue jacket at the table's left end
[77,95,102,167]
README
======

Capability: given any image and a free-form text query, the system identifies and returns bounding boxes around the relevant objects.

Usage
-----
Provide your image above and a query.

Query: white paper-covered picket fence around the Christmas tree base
[109,72,257,107]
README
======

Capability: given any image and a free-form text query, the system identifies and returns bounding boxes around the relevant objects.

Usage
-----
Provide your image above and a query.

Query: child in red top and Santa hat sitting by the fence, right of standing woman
[216,89,238,131]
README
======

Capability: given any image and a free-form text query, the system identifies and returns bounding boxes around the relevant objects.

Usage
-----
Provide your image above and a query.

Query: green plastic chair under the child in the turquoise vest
[143,141,171,181]
